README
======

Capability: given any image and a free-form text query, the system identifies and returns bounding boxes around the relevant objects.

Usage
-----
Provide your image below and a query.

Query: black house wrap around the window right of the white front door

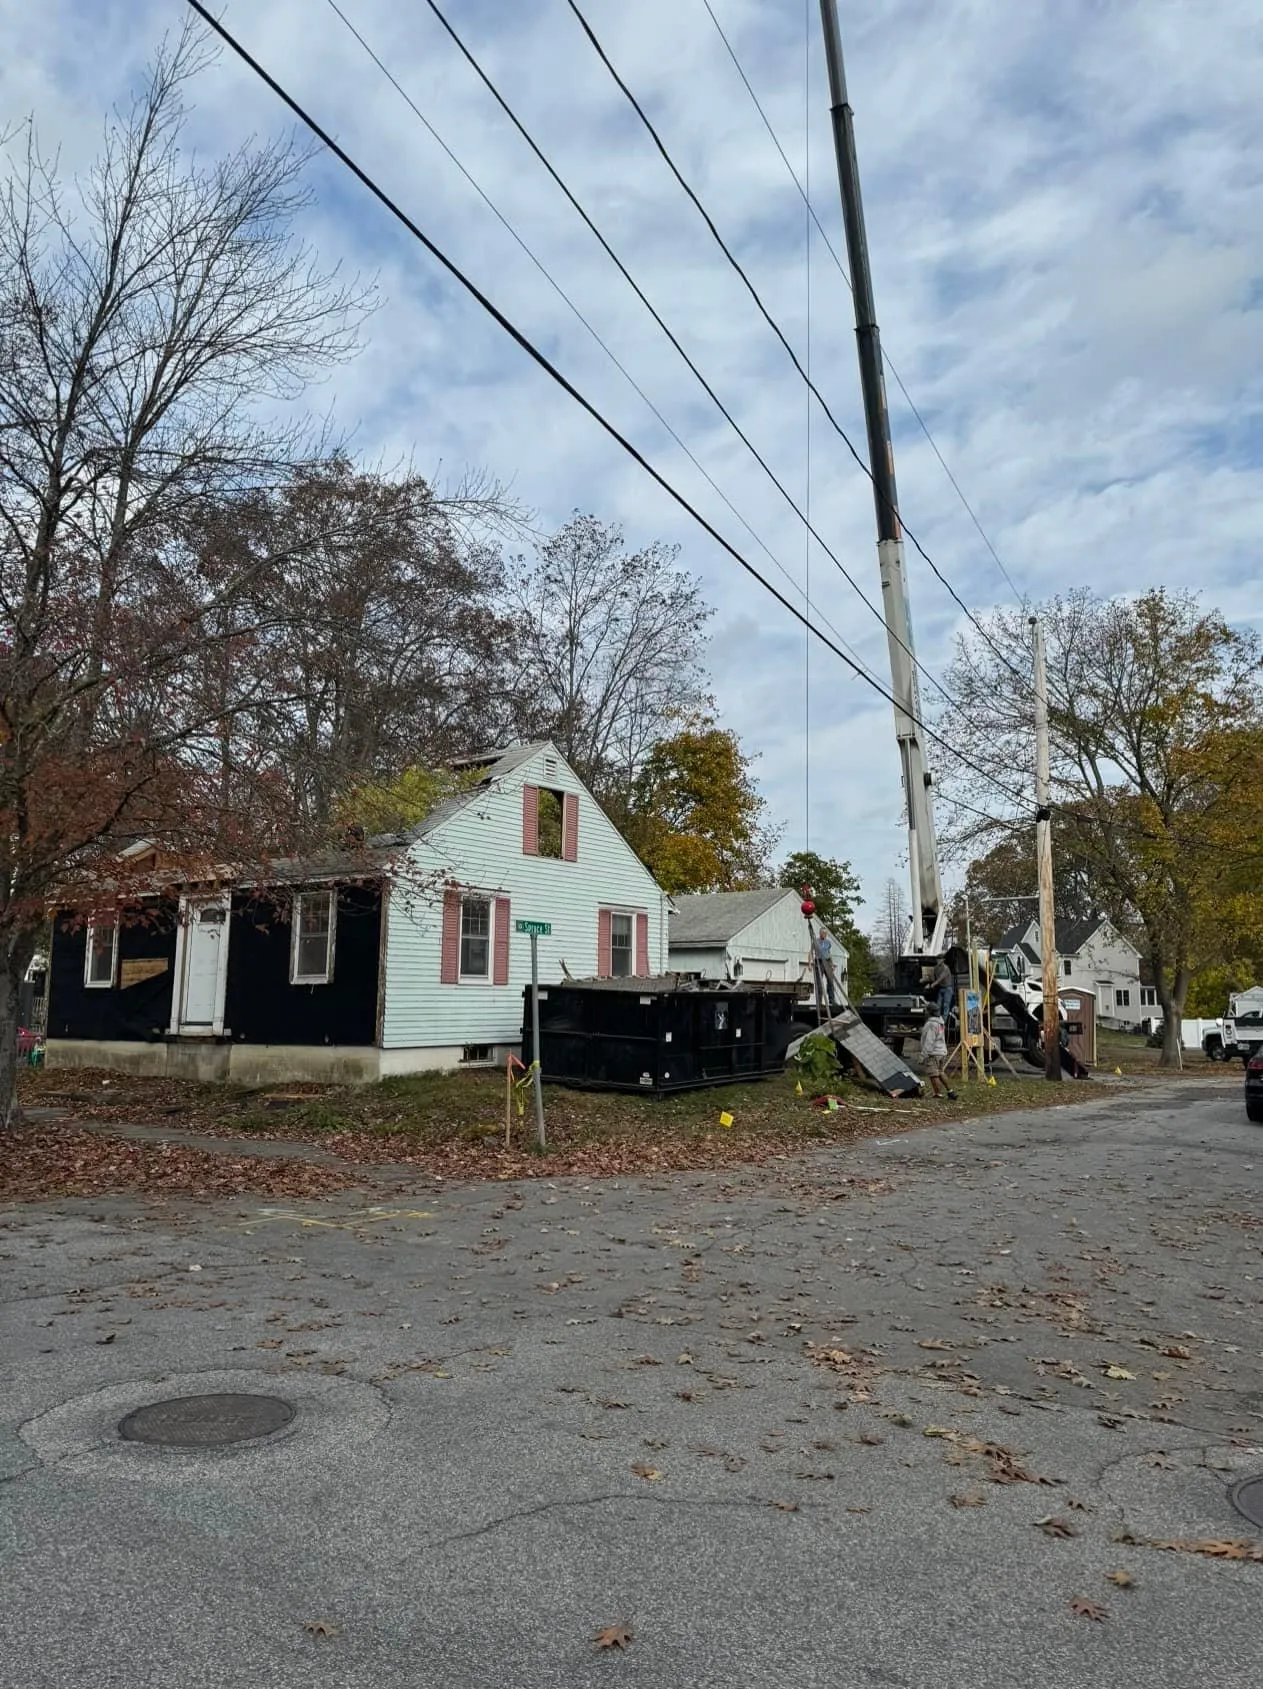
[223,885,382,1044]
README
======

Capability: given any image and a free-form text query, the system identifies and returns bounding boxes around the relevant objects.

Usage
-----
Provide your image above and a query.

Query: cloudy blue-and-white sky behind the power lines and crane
[0,0,1263,919]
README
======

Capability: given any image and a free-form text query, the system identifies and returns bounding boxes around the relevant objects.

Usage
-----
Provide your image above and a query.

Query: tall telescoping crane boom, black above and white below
[821,0,946,956]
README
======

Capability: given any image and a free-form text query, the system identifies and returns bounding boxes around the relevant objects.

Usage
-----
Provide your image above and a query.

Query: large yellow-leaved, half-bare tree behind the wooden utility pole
[944,589,1263,1064]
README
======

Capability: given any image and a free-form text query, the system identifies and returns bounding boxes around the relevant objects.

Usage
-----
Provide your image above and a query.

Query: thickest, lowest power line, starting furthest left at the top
[187,0,1025,807]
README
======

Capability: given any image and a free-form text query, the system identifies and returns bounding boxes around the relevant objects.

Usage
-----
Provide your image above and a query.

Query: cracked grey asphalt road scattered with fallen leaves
[0,1081,1263,1689]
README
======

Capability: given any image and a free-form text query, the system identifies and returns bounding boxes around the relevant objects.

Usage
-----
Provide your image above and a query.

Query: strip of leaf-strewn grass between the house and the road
[0,1069,1101,1199]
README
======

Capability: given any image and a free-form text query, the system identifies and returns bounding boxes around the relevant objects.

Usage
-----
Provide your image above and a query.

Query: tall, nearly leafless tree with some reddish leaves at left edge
[0,32,370,1125]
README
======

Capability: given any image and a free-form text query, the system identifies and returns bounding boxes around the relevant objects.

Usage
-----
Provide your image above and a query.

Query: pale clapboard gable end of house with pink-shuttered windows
[377,743,670,1076]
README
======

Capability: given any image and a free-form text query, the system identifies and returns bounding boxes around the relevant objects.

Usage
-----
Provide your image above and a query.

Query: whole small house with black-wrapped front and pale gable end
[47,743,669,1084]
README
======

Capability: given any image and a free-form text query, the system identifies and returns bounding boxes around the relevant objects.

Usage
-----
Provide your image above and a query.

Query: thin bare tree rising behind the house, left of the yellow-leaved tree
[507,512,711,807]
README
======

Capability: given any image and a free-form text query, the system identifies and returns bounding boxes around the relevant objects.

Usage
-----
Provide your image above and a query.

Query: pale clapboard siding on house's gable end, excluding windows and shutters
[382,745,667,1059]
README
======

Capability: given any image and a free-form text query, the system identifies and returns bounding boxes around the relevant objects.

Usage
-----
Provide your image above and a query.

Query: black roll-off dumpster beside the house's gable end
[522,975,807,1096]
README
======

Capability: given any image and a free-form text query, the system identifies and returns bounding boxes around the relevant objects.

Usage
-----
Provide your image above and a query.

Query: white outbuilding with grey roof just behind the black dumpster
[667,887,846,990]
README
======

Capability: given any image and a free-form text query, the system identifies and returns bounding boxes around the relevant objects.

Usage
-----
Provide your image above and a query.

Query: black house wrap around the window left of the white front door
[47,899,177,1042]
